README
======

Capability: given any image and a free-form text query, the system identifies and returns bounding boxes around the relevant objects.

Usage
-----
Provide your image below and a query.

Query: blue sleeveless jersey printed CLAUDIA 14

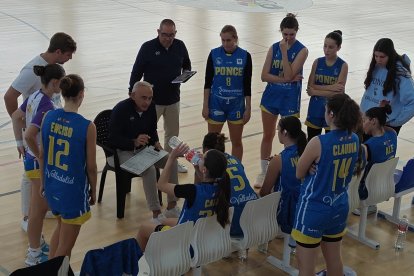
[297,130,359,210]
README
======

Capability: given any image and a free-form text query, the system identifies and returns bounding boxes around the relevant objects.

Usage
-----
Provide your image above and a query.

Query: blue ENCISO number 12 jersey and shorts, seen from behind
[41,109,90,218]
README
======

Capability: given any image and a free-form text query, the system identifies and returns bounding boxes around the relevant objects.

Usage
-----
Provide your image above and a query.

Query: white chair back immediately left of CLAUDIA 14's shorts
[240,192,280,249]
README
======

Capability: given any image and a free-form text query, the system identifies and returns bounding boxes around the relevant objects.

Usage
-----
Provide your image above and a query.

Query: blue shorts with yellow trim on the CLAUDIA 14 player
[292,202,349,245]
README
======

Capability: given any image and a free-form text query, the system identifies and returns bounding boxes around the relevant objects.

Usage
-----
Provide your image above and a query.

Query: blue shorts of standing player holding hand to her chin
[260,83,302,117]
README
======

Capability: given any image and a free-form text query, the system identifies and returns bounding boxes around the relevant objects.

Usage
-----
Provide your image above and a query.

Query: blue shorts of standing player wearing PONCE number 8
[208,94,245,124]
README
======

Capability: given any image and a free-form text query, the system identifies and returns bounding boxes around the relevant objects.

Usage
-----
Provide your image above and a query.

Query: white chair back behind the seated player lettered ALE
[361,157,399,206]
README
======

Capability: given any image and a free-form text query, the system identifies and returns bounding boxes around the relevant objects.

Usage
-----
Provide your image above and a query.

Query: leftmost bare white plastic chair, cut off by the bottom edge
[138,221,193,276]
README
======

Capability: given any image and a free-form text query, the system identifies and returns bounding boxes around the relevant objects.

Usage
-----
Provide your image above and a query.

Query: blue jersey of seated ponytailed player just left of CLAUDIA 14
[274,145,301,234]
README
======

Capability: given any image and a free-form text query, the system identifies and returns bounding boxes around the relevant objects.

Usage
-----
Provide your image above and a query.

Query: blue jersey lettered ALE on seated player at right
[364,130,397,164]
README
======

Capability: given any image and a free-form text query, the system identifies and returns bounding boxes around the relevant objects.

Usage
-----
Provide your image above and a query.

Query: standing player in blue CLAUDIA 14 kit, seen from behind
[292,93,361,275]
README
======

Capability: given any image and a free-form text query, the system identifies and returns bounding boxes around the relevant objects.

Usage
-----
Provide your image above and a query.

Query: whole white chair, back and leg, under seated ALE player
[348,157,398,249]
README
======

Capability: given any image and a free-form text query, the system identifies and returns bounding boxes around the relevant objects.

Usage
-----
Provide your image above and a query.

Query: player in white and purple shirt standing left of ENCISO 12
[12,64,65,266]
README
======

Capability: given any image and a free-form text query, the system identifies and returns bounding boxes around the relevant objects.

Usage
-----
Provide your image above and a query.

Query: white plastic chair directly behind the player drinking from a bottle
[190,207,233,275]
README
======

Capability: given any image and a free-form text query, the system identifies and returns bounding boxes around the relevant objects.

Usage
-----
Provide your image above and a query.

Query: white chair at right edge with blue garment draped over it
[378,159,414,231]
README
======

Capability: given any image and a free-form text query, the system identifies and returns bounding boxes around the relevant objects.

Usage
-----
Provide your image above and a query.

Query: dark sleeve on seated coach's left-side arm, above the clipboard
[108,106,135,150]
